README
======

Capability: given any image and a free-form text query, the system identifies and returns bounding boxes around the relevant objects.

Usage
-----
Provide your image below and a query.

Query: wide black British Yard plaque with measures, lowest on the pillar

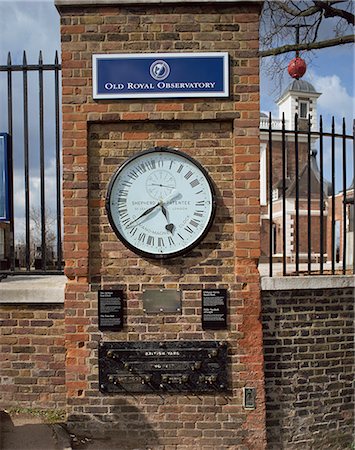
[99,341,228,394]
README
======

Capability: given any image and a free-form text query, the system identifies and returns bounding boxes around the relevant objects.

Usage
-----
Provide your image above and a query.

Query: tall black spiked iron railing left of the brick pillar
[0,52,63,275]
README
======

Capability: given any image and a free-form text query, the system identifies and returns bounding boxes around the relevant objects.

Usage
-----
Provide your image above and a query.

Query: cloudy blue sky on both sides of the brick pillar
[0,0,355,237]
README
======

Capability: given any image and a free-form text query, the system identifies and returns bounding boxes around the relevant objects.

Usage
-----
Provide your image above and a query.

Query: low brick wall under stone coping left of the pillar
[0,305,65,409]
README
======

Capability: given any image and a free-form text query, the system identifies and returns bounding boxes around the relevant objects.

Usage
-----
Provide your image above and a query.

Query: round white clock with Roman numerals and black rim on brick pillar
[106,147,216,259]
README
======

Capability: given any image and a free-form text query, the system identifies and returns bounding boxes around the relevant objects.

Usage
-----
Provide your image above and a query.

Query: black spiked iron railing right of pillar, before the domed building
[259,113,355,276]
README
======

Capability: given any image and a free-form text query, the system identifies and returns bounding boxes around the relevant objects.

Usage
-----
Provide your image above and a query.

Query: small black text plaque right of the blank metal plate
[202,289,227,330]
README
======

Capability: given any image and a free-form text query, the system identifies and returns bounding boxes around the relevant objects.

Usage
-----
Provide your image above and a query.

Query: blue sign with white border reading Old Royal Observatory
[93,52,229,99]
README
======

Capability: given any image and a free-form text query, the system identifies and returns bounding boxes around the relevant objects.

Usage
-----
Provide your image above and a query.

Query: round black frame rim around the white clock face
[105,147,216,259]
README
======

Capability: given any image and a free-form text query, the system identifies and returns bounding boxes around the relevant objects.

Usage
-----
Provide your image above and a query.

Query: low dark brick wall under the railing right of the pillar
[263,284,355,450]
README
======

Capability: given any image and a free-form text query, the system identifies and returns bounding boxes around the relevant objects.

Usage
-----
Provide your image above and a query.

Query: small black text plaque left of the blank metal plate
[99,290,123,331]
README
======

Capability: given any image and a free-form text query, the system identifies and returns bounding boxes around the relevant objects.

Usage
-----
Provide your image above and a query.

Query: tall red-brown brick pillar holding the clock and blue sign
[60,3,265,449]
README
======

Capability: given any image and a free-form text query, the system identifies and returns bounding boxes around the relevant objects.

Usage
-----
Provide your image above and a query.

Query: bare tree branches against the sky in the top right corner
[259,0,355,84]
